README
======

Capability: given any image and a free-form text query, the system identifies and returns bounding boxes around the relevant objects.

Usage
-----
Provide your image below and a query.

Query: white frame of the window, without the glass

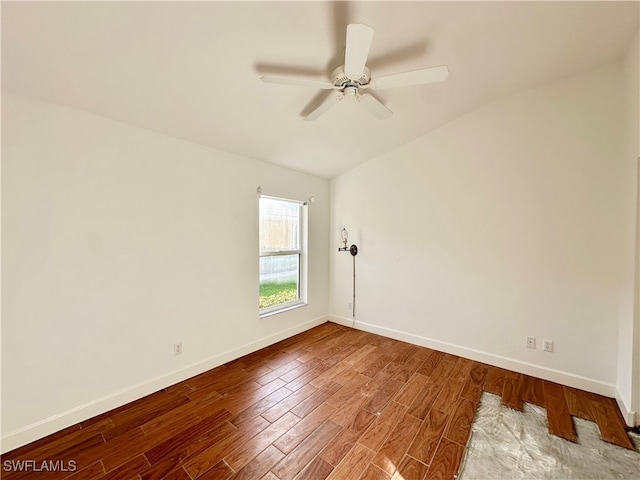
[258,195,308,318]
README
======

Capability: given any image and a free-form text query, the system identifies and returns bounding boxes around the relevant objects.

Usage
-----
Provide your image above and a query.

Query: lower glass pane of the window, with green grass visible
[260,254,300,308]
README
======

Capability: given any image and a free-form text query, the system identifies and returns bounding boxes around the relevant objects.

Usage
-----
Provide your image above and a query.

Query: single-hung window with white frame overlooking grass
[259,196,306,316]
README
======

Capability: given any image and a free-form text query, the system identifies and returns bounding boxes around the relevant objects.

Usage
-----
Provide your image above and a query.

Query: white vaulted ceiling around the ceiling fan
[2,1,639,178]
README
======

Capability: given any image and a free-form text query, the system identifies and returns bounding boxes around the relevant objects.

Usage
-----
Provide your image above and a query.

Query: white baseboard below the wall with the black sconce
[329,315,617,398]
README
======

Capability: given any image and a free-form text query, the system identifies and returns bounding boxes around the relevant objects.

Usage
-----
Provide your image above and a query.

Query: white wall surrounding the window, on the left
[2,93,329,451]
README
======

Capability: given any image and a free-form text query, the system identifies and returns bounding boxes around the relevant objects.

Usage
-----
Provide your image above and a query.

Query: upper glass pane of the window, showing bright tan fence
[260,198,300,251]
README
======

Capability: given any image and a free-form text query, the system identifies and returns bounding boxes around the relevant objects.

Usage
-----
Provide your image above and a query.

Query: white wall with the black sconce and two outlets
[330,62,635,402]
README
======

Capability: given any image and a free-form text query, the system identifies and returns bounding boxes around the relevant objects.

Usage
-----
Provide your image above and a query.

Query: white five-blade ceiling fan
[261,23,449,121]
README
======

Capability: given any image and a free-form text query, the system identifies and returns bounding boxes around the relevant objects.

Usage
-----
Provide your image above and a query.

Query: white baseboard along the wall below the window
[0,315,329,453]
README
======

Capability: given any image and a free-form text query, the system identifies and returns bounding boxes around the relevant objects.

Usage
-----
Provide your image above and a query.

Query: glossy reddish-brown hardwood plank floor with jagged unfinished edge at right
[2,323,633,480]
